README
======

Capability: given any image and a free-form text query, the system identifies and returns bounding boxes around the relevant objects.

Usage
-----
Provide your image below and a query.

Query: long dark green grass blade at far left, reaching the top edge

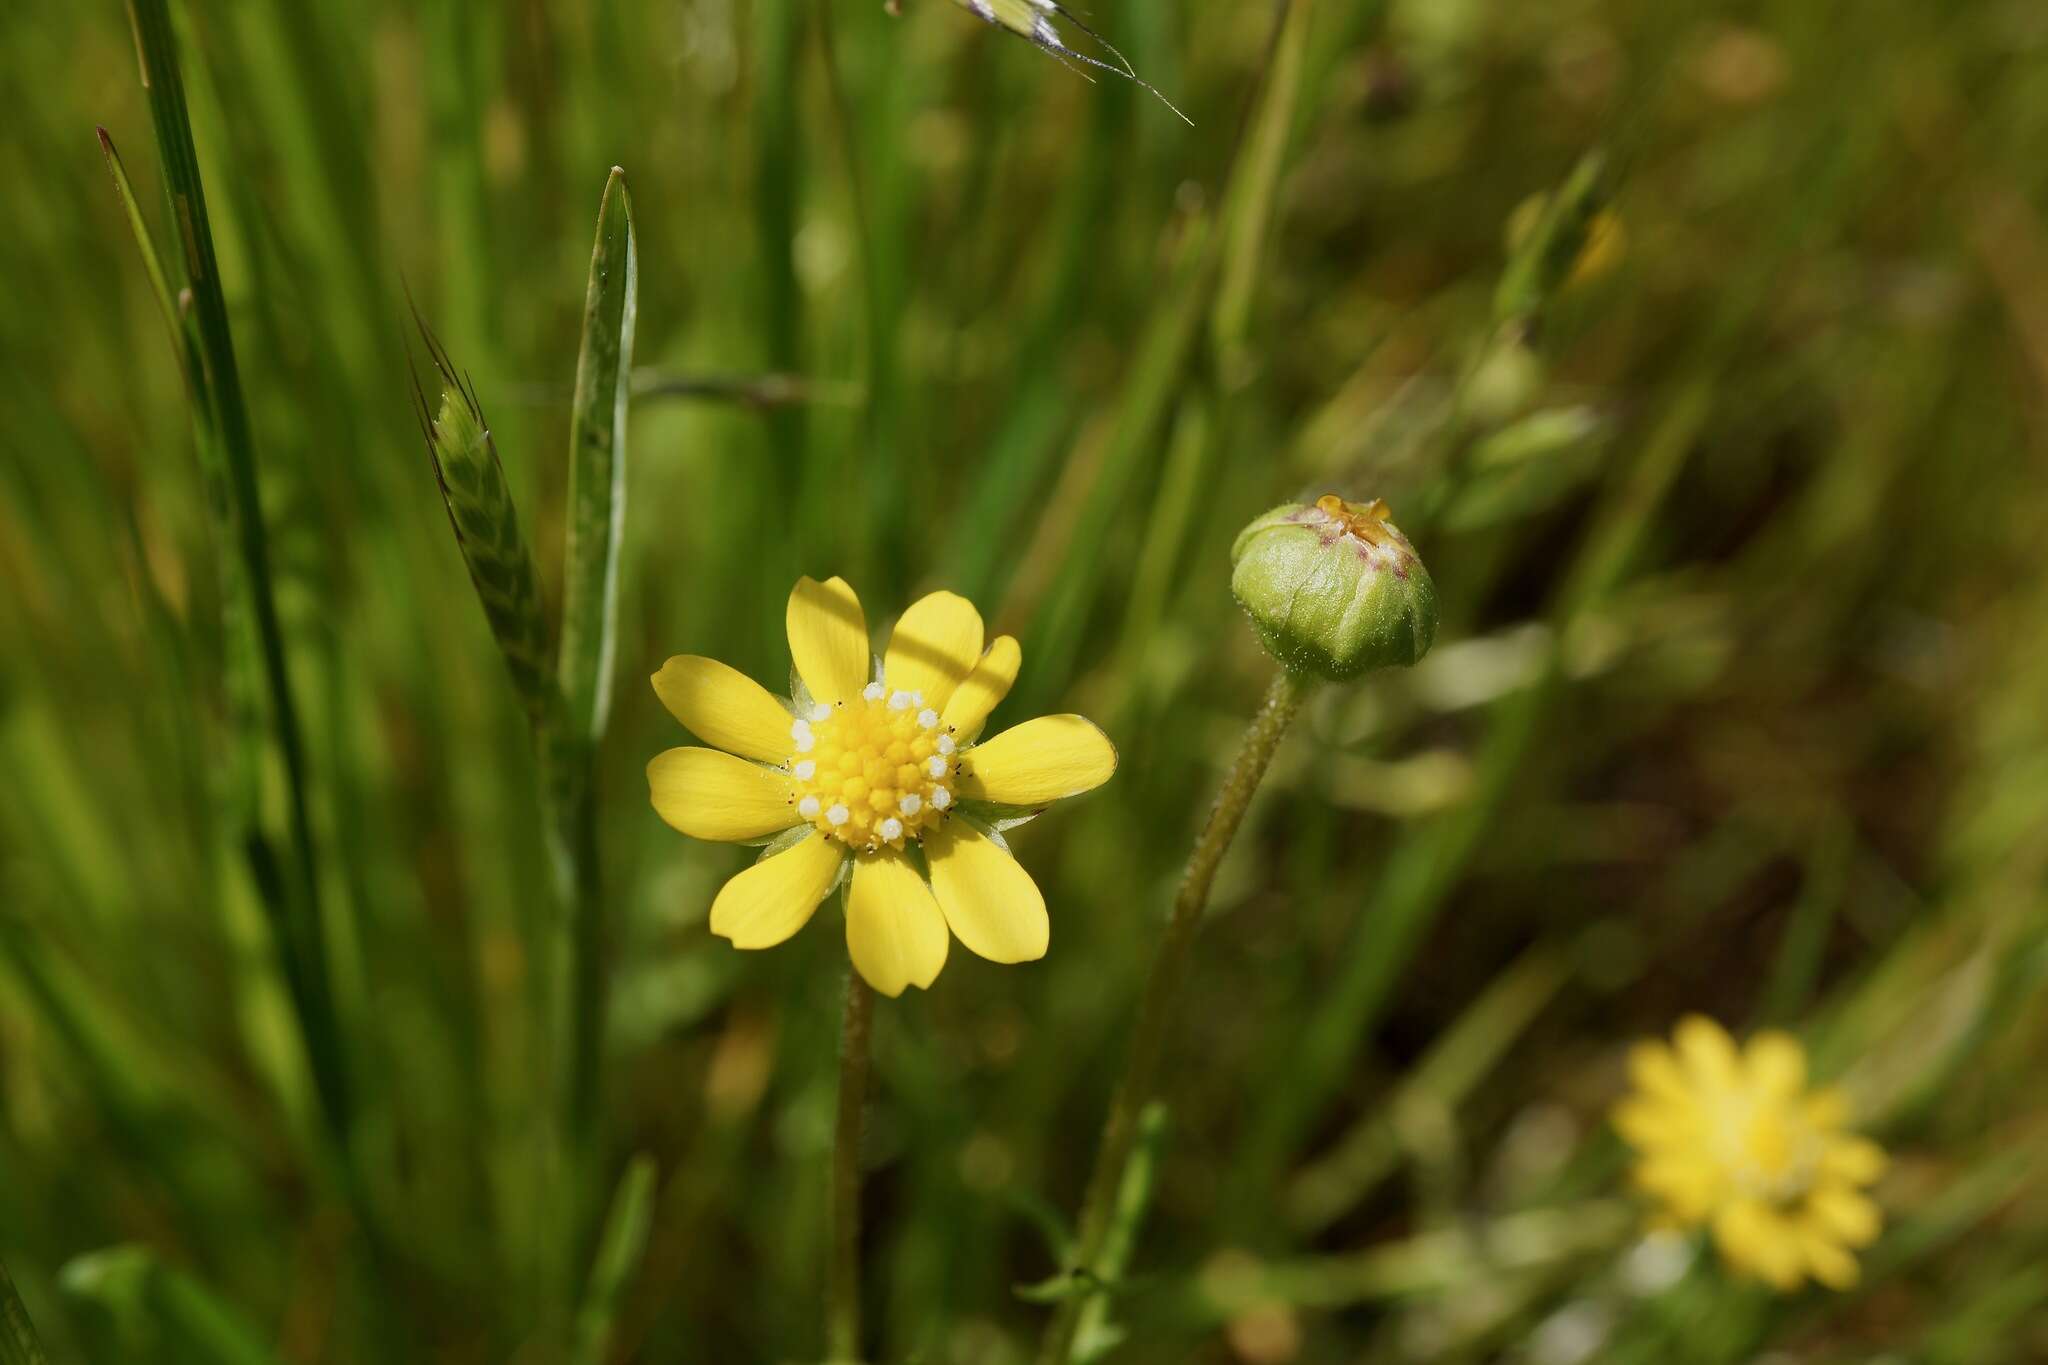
[129,0,352,1144]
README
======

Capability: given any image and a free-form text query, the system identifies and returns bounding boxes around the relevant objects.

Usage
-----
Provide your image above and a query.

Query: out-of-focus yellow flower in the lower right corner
[1614,1015,1884,1291]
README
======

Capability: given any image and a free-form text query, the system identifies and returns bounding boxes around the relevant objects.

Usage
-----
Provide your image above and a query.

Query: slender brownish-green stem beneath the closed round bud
[1038,669,1315,1365]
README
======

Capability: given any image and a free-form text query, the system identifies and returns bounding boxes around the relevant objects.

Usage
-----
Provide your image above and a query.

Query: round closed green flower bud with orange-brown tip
[1231,493,1436,679]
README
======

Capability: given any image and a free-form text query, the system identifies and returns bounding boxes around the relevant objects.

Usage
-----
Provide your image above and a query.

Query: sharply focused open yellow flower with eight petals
[647,579,1116,995]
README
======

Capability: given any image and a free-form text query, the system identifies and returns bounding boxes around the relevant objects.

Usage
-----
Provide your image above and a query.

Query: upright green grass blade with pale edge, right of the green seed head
[557,166,639,743]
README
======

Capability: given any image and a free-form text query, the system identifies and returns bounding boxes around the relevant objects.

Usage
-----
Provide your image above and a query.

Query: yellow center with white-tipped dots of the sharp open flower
[784,684,961,853]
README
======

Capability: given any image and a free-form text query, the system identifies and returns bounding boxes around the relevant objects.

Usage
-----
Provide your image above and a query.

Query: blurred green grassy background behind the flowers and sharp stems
[0,0,2048,1365]
